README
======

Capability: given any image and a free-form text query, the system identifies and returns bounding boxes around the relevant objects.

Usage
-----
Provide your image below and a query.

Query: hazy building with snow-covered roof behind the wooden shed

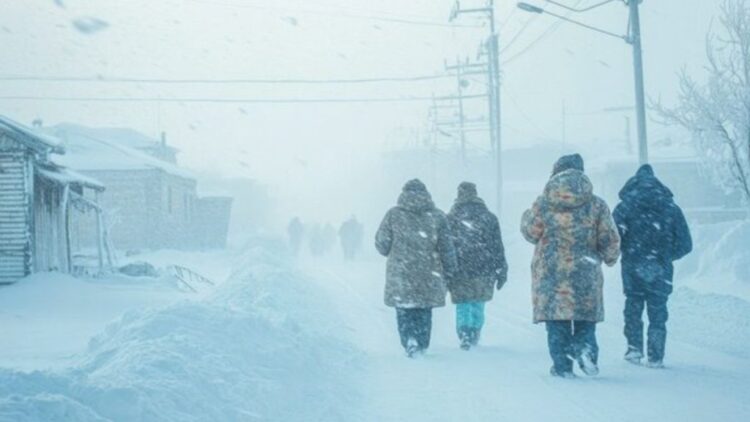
[47,124,232,250]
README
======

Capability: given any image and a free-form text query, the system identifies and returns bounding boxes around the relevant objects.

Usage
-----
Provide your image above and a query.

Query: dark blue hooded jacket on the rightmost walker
[612,165,693,295]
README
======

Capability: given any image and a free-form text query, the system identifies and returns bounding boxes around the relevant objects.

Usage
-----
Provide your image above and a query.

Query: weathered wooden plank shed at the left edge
[0,116,106,284]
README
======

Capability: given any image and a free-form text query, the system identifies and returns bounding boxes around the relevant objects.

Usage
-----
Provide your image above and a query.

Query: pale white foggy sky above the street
[0,0,717,234]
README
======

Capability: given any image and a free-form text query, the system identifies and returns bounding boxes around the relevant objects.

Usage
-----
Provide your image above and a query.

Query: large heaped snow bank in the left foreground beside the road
[0,242,360,421]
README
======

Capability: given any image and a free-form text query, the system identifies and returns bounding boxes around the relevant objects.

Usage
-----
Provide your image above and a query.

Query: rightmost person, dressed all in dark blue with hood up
[613,164,693,368]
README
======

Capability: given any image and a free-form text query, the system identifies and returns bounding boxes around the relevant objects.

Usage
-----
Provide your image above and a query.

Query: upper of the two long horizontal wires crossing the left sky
[0,74,454,85]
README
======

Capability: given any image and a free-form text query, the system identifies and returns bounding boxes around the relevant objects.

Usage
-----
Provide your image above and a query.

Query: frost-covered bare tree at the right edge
[655,0,750,205]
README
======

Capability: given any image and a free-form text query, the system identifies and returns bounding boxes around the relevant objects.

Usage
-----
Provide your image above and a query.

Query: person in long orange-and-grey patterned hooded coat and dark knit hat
[521,154,620,378]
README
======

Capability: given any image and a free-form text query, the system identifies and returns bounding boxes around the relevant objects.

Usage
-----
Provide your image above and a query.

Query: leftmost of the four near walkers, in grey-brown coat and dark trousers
[375,179,457,357]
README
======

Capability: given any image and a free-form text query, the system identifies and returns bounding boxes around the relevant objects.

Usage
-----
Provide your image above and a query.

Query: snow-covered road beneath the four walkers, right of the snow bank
[306,241,750,422]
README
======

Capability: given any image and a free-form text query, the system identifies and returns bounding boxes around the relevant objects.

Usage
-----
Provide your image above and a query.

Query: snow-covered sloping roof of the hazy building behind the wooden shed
[47,125,194,179]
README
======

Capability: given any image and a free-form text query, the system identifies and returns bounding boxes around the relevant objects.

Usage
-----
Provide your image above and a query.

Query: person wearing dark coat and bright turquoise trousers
[448,182,508,350]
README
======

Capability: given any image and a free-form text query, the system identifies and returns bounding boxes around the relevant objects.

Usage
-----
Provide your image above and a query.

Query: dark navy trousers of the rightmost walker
[624,293,669,362]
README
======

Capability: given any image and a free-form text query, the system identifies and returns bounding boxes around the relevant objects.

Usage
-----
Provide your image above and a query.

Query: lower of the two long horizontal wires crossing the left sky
[0,95,485,104]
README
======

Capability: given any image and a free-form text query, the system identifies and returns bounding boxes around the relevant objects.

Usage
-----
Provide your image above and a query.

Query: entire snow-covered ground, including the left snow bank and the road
[0,228,750,422]
